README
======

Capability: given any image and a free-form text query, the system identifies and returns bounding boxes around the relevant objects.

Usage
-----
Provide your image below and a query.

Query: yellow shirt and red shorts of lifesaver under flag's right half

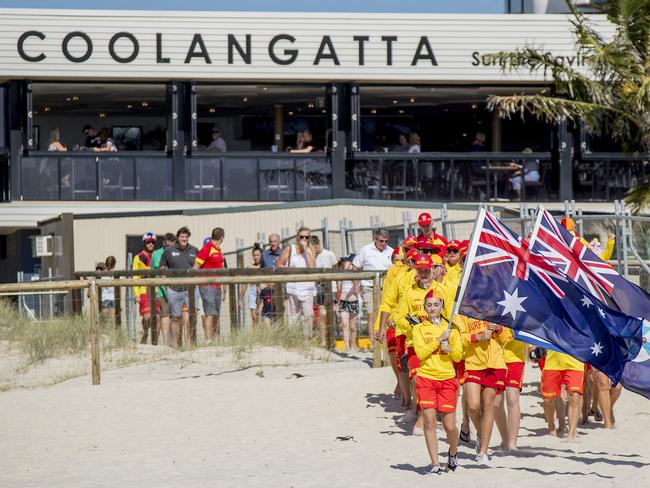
[542,349,585,398]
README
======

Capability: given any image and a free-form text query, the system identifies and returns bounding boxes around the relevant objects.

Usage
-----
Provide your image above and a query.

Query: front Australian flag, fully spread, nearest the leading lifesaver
[458,210,642,383]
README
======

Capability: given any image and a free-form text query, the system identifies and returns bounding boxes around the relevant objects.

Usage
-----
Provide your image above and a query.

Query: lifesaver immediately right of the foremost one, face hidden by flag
[459,315,512,465]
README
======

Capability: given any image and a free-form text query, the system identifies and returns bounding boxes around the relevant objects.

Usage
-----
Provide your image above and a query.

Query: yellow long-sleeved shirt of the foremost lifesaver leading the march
[413,319,463,381]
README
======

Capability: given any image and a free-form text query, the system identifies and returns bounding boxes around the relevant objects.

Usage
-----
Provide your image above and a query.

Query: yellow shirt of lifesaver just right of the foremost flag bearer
[455,315,513,371]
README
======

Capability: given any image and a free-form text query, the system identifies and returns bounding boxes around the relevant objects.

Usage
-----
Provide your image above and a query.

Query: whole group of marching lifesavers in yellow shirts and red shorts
[375,213,621,474]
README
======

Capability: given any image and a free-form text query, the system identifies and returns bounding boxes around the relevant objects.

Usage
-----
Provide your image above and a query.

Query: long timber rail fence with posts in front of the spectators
[0,268,388,385]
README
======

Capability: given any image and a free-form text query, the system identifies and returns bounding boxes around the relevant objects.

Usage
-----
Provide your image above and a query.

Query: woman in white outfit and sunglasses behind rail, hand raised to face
[277,227,316,337]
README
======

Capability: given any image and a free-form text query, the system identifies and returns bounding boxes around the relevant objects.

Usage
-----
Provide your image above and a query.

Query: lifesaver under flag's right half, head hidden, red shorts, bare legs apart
[542,350,585,439]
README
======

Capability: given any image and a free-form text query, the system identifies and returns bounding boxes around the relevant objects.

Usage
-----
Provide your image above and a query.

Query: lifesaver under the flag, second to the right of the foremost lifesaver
[494,340,526,452]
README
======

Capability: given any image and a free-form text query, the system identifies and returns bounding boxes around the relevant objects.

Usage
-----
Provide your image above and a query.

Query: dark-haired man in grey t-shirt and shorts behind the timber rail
[160,227,199,346]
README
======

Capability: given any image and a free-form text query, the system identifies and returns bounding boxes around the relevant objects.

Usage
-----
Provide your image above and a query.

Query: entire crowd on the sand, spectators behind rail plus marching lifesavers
[98,212,621,474]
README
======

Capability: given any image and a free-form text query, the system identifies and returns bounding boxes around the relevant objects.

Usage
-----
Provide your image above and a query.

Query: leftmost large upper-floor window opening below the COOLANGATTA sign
[32,82,167,152]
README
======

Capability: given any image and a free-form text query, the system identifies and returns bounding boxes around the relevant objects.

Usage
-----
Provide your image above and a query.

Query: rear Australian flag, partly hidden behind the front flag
[530,207,650,398]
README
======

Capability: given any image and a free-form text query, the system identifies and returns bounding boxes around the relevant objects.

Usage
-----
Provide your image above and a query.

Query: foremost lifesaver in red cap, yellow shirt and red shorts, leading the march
[413,290,463,474]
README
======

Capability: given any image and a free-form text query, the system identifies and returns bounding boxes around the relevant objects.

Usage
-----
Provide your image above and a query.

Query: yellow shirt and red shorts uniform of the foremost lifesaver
[413,318,463,413]
